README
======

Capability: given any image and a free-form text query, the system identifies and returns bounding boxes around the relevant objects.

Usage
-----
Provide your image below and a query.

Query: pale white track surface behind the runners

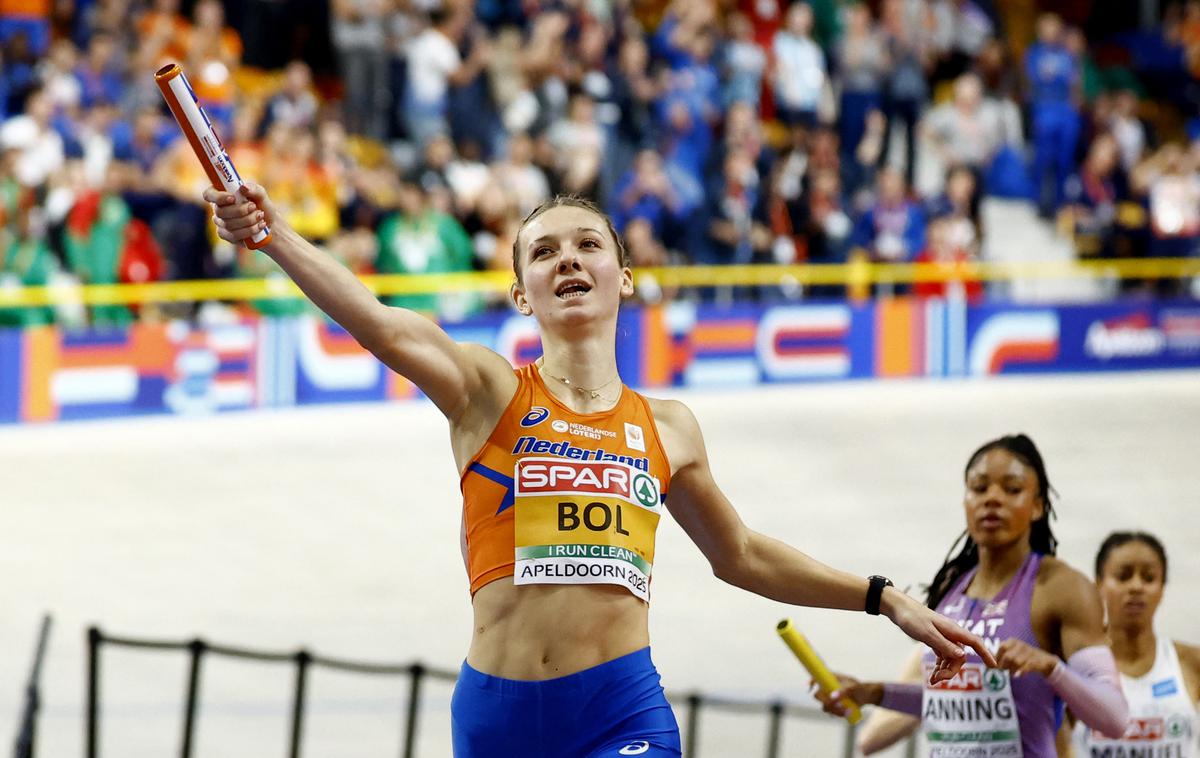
[0,373,1200,758]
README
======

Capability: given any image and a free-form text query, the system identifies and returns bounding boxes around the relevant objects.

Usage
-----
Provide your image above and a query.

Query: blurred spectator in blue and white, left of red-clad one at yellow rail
[851,168,925,263]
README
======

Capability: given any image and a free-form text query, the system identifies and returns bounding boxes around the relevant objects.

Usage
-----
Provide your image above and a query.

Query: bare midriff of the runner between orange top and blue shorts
[467,577,650,681]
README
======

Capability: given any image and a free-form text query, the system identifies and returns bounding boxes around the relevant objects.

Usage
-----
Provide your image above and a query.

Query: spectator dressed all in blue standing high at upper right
[1025,13,1081,217]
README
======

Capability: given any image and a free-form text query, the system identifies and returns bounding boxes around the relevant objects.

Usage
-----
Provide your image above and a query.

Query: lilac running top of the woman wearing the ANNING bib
[924,553,1062,758]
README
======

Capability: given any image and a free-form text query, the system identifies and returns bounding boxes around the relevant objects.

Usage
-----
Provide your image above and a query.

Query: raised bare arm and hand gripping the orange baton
[204,184,515,422]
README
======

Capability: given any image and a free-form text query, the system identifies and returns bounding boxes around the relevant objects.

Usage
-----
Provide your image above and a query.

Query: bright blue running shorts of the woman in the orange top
[450,648,683,758]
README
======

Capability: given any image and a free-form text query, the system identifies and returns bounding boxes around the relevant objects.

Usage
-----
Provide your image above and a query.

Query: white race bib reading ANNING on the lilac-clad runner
[922,663,1022,758]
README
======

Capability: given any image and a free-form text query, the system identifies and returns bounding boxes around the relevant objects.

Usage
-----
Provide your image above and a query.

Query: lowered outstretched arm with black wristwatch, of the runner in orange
[654,401,995,681]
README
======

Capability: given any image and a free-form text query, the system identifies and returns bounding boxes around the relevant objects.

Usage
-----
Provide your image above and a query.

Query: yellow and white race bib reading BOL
[514,458,662,601]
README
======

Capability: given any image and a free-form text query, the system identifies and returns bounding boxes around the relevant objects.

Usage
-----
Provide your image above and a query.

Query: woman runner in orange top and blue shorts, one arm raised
[204,185,991,758]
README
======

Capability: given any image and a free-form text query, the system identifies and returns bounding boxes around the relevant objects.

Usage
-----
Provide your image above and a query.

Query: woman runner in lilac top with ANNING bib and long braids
[821,434,1128,758]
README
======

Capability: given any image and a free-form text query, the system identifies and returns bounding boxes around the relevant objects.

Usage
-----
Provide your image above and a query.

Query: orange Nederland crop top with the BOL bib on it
[461,365,671,601]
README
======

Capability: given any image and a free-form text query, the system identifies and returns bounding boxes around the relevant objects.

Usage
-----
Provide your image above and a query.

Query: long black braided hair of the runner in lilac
[925,434,1058,609]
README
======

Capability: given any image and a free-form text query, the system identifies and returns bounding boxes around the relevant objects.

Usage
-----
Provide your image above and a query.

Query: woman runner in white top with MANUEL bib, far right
[1075,531,1200,758]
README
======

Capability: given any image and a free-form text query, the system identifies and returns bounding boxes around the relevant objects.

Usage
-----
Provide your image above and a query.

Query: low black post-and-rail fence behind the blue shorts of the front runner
[85,626,913,758]
